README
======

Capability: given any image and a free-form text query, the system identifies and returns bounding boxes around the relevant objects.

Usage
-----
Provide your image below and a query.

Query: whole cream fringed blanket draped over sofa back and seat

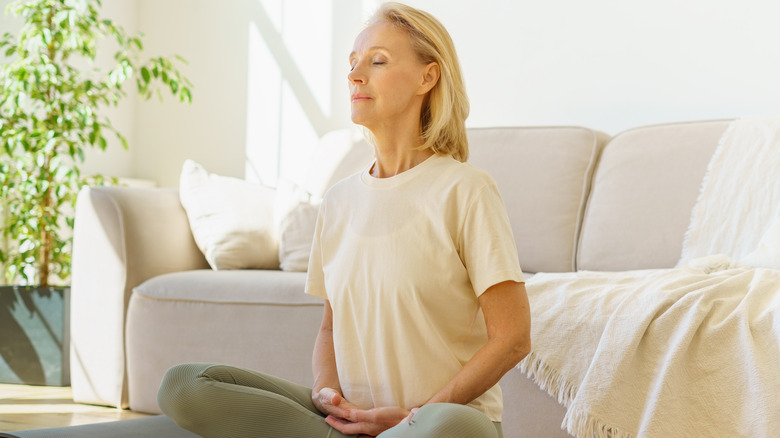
[520,120,780,438]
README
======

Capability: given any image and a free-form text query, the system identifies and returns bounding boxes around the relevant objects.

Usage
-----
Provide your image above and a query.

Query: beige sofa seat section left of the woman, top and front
[126,270,323,413]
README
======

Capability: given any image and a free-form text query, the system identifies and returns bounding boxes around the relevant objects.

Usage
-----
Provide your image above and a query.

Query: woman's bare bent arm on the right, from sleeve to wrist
[426,281,531,404]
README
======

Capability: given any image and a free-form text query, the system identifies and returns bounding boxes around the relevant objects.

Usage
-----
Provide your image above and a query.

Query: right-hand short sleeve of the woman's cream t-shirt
[459,183,525,296]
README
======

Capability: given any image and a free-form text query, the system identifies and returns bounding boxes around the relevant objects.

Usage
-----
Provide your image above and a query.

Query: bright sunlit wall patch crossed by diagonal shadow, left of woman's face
[246,0,333,186]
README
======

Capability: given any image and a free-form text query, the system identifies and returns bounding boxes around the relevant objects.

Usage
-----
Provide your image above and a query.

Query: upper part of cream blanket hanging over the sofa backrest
[680,117,780,269]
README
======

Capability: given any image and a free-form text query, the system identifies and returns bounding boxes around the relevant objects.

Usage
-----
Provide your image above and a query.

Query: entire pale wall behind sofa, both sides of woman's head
[0,0,780,187]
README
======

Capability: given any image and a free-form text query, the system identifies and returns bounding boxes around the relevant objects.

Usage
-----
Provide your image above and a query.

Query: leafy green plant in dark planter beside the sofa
[0,0,191,384]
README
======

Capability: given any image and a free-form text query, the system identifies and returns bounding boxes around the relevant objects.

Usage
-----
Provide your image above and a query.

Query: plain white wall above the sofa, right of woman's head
[410,0,780,130]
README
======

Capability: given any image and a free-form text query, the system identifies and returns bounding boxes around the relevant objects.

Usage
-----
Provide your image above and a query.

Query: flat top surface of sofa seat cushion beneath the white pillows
[133,269,322,305]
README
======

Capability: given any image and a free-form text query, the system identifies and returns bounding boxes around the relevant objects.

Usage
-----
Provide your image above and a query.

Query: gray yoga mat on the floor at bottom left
[0,415,199,438]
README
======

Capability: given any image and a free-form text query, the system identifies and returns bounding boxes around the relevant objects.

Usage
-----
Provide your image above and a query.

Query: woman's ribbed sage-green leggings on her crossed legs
[157,363,503,438]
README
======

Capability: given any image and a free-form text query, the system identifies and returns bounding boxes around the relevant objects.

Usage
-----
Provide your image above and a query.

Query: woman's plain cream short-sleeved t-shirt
[306,155,523,421]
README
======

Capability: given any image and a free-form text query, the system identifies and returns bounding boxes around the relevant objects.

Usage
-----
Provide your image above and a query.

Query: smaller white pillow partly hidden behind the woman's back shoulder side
[274,180,320,272]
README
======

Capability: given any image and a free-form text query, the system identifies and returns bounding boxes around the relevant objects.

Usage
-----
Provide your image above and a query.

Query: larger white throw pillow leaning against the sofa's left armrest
[179,160,279,270]
